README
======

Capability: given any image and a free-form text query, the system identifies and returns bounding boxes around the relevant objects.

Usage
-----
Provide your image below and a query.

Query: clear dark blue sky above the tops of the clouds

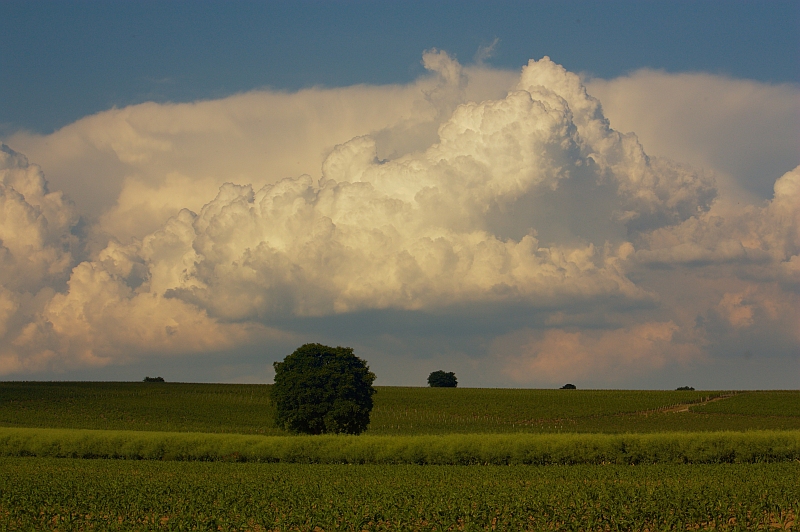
[0,0,800,133]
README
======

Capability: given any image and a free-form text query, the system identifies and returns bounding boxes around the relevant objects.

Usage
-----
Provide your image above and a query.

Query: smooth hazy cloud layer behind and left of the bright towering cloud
[3,51,514,240]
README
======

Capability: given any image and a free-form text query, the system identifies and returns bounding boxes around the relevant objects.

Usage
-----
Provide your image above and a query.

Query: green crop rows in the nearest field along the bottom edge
[0,458,800,531]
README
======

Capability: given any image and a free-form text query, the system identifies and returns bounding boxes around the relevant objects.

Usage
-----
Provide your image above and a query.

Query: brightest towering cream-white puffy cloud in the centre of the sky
[141,59,713,321]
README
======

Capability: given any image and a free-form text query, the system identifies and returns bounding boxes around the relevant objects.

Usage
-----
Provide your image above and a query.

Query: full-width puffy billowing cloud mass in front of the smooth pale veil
[0,52,800,383]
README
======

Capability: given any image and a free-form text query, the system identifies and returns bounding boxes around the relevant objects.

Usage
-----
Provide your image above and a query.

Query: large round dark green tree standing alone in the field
[272,344,375,434]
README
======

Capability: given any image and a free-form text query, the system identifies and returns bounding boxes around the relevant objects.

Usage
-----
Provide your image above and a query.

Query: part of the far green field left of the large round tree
[0,382,283,434]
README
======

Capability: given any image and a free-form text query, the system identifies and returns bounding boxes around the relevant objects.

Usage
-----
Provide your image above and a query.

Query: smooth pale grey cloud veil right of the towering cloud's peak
[587,69,800,204]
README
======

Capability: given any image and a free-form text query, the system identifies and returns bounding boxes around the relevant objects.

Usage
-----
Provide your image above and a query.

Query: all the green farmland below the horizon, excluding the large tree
[0,383,800,531]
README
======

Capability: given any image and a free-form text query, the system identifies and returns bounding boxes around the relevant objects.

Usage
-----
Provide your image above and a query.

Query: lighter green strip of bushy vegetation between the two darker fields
[0,428,800,465]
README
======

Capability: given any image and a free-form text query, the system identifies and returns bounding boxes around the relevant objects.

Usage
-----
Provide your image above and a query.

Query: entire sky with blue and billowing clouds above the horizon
[0,1,800,389]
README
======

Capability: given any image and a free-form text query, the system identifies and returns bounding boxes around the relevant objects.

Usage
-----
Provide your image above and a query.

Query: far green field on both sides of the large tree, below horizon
[0,382,800,435]
